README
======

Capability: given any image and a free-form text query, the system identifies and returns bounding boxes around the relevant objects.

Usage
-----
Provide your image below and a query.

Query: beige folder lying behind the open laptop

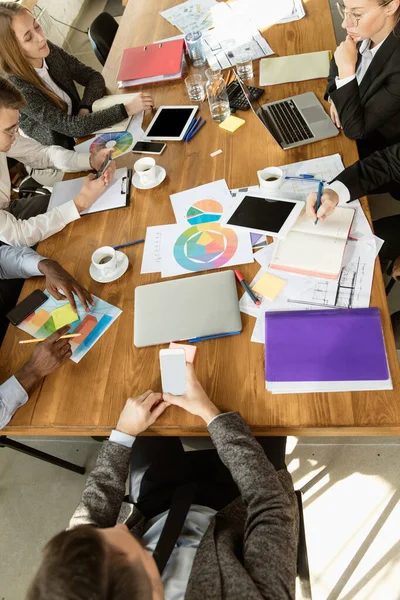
[260,50,331,87]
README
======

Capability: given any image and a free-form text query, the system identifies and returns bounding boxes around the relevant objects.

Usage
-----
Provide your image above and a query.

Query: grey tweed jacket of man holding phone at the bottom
[70,413,298,600]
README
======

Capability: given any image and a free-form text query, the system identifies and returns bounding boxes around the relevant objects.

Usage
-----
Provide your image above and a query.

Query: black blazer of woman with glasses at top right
[325,26,400,158]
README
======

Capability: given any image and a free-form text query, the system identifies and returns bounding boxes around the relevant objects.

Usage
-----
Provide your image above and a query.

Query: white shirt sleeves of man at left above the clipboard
[0,136,91,246]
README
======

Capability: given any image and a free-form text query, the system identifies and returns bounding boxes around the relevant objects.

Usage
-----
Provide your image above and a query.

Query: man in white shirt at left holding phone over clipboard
[0,77,115,246]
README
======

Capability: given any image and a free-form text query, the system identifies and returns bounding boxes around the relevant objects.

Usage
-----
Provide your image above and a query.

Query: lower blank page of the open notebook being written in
[270,230,346,279]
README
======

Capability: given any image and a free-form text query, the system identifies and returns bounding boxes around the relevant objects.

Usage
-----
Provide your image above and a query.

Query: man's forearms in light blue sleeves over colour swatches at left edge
[0,246,93,429]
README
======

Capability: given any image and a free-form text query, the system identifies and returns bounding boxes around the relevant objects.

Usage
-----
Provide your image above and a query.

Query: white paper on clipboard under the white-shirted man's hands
[47,168,128,215]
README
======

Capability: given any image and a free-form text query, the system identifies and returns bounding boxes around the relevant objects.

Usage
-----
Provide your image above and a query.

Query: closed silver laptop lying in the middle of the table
[133,270,242,348]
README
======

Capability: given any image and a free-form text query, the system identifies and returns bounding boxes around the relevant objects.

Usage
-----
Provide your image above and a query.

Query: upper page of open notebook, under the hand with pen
[292,206,355,241]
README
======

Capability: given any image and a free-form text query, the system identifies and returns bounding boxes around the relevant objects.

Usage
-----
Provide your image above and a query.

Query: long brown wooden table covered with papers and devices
[0,0,400,436]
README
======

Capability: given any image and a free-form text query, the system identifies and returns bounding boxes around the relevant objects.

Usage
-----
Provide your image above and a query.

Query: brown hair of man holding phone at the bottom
[26,525,152,600]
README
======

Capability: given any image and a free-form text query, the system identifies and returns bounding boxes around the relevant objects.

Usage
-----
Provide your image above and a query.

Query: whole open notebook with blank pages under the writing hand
[270,206,355,279]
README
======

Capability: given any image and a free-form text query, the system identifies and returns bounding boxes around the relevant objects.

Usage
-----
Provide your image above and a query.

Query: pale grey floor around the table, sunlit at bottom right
[0,0,400,600]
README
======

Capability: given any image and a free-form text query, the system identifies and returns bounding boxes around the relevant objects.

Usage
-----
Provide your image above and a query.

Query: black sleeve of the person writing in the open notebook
[335,144,400,200]
